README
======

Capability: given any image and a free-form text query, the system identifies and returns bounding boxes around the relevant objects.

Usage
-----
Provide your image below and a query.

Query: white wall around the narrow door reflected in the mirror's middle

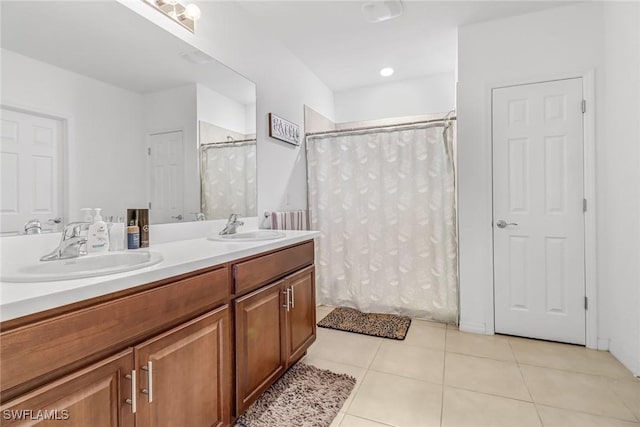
[144,84,201,218]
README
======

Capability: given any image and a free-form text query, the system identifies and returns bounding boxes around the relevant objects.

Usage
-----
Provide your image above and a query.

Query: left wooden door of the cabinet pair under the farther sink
[235,281,286,414]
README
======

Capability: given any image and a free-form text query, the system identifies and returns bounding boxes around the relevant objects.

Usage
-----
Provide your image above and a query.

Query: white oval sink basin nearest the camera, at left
[0,251,162,282]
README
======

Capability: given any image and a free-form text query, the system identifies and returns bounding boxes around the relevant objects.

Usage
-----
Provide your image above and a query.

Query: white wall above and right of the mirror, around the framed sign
[118,0,334,212]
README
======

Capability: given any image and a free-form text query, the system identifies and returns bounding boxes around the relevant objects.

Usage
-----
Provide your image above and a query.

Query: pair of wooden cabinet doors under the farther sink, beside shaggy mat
[235,267,316,414]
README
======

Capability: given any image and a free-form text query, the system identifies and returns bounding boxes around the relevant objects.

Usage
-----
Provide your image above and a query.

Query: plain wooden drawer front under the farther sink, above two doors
[233,241,314,296]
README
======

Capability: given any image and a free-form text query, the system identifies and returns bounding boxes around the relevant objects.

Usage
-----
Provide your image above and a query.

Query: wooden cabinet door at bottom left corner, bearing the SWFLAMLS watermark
[1,349,134,427]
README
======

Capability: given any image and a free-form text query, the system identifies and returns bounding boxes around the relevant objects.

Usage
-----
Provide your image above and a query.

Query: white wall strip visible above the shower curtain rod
[334,72,456,122]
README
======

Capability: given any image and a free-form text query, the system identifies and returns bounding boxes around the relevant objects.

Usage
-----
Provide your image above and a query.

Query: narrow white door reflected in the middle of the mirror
[149,131,184,224]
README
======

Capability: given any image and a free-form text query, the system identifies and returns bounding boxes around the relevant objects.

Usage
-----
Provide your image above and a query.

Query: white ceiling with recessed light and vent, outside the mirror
[240,0,568,91]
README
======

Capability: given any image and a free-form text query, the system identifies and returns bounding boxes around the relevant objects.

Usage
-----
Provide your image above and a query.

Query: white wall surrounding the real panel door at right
[457,2,640,373]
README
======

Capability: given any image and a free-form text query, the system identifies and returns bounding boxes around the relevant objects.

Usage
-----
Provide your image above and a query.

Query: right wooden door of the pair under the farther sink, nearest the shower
[285,267,316,367]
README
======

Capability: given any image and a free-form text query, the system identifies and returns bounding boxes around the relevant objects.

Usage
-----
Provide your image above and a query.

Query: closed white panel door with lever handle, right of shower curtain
[492,78,586,344]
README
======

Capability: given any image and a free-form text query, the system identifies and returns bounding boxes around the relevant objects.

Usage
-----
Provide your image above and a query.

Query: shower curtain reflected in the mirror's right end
[200,141,257,219]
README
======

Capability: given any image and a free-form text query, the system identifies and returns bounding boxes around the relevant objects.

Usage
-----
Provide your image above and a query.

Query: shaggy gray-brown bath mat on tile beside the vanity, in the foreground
[236,363,356,427]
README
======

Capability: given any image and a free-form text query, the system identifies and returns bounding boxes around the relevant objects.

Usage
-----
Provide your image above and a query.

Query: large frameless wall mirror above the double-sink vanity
[0,0,256,235]
